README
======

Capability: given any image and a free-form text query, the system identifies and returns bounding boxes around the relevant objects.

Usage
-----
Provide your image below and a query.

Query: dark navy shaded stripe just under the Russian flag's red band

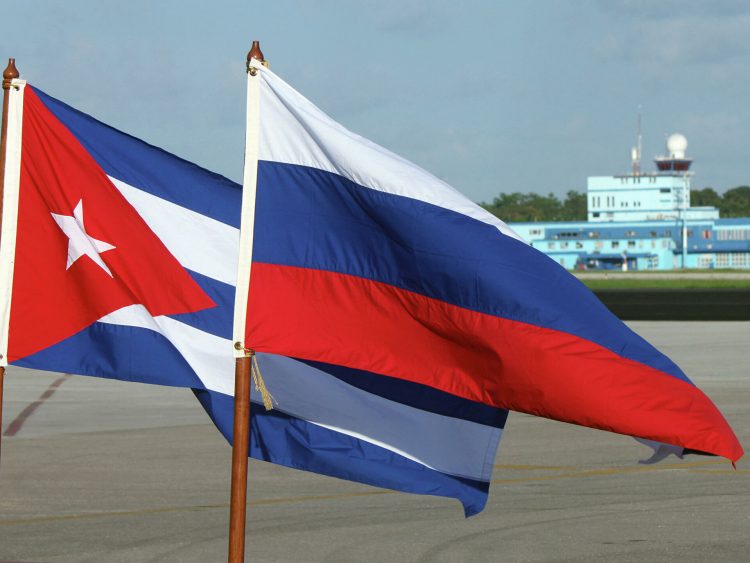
[298,360,508,428]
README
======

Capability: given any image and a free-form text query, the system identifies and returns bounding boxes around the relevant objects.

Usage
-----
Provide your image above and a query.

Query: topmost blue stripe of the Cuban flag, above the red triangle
[34,88,242,228]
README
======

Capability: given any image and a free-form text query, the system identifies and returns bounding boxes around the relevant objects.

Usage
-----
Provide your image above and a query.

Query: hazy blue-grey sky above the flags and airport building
[0,0,750,201]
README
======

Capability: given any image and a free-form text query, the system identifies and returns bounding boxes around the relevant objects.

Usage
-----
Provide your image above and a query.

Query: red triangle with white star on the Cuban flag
[8,87,215,361]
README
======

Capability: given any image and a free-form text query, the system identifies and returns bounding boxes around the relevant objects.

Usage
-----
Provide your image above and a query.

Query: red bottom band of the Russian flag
[247,263,742,460]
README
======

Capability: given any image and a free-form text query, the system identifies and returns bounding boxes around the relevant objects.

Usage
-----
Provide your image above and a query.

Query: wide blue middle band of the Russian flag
[253,161,689,381]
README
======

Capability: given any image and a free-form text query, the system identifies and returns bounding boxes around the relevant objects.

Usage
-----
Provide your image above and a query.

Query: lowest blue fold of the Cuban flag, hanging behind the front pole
[194,390,489,517]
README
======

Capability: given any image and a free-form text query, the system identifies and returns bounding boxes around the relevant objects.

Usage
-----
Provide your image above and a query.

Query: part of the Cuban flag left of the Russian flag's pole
[0,80,241,395]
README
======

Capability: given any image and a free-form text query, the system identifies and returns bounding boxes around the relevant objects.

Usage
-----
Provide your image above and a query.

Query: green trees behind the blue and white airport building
[480,186,750,223]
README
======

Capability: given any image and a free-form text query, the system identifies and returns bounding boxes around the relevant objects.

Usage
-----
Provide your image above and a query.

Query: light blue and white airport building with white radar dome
[510,134,750,270]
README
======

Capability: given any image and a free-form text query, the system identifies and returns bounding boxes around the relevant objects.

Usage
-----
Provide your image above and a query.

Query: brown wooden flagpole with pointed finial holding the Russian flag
[229,41,267,563]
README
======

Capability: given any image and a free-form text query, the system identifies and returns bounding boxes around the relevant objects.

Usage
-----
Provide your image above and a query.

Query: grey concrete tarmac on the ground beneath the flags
[0,322,750,563]
